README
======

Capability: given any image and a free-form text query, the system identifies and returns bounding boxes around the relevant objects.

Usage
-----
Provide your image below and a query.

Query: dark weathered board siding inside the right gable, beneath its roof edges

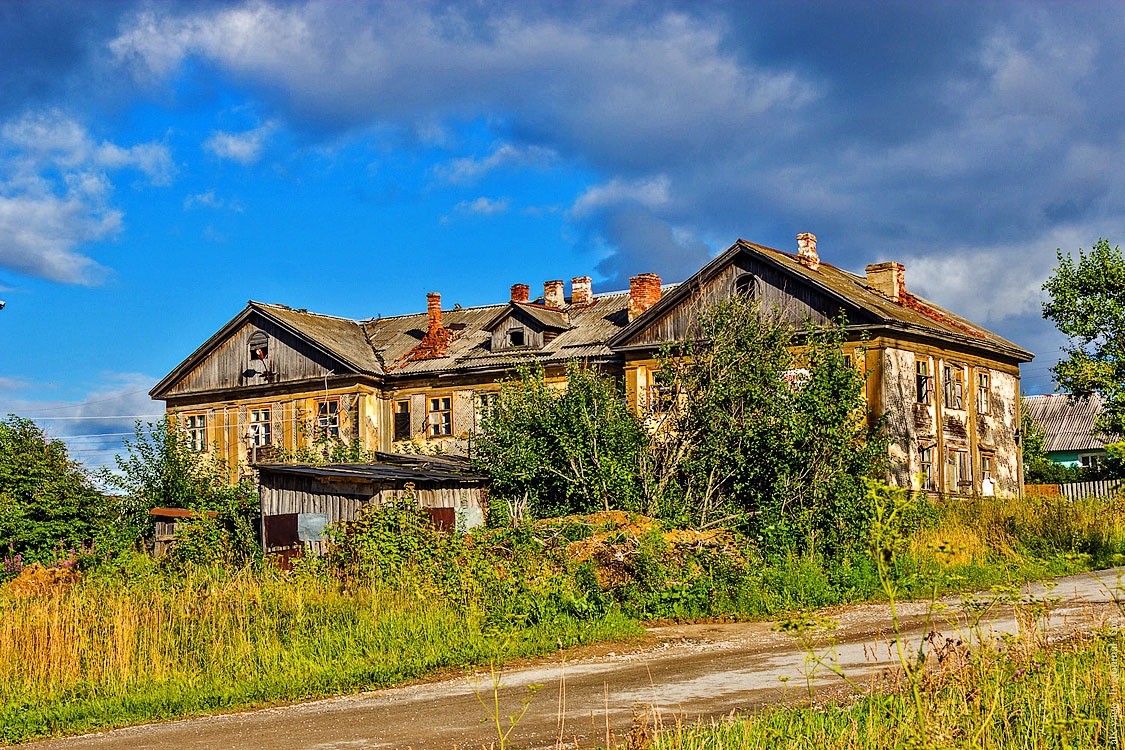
[627,255,842,346]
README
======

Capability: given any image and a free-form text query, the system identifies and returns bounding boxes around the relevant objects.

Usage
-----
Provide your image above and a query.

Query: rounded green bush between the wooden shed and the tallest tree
[474,361,647,516]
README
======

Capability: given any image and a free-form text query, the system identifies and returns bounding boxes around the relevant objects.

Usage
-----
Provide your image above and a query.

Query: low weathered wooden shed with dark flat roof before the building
[254,453,485,554]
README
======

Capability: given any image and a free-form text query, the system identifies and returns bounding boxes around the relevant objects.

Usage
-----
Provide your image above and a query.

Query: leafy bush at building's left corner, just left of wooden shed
[99,416,260,559]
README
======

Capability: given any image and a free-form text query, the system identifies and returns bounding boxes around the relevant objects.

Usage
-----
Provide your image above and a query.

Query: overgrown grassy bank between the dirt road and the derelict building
[0,490,1125,747]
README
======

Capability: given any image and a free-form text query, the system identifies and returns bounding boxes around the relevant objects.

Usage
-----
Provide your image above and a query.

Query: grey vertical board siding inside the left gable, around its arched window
[168,316,348,396]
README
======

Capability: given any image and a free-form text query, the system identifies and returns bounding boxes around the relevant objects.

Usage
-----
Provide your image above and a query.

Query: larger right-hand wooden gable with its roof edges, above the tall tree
[611,245,870,349]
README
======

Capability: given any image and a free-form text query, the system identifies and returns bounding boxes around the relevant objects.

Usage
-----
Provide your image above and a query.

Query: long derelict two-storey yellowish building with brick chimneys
[152,234,1032,494]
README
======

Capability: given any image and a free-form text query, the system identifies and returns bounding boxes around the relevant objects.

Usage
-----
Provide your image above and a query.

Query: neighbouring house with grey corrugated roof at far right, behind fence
[1024,394,1115,469]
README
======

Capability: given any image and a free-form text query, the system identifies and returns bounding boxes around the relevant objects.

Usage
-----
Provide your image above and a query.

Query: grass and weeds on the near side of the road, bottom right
[650,633,1125,750]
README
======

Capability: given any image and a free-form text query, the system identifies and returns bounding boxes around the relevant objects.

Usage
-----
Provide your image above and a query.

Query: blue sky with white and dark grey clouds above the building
[0,1,1125,464]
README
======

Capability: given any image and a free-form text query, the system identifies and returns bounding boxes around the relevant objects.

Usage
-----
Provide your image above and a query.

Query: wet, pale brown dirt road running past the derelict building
[23,568,1125,750]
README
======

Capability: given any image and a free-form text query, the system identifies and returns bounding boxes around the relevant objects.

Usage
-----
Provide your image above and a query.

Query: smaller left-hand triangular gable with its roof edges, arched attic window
[152,309,356,398]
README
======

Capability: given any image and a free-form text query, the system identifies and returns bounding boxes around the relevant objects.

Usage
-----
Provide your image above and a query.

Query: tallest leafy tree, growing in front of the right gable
[645,297,888,550]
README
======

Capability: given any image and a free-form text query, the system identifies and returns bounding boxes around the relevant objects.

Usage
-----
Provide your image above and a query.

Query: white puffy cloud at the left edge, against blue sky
[0,110,174,284]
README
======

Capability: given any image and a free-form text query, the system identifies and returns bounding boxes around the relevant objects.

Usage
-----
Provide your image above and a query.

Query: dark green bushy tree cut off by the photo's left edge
[0,415,108,559]
